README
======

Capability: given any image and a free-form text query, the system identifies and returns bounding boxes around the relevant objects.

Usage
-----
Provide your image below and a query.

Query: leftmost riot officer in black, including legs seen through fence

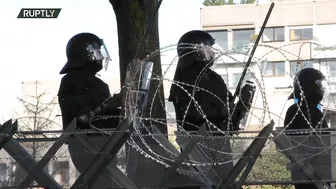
[58,33,121,189]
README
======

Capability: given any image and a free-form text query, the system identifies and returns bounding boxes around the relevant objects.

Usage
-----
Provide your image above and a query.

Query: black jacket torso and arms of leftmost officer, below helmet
[58,68,120,129]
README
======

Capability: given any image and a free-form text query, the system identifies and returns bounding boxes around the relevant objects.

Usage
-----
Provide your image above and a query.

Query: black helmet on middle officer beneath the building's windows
[177,30,215,61]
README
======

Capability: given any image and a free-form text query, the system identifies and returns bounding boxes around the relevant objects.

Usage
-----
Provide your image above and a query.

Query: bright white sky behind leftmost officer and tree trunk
[0,0,268,111]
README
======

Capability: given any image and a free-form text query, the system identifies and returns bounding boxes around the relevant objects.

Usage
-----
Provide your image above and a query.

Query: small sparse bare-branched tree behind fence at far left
[9,81,69,186]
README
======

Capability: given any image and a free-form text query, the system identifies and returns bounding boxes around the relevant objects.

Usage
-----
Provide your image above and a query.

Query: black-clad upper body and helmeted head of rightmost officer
[284,68,329,189]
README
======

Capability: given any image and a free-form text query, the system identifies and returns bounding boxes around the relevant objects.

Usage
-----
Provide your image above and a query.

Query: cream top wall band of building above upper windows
[201,0,336,30]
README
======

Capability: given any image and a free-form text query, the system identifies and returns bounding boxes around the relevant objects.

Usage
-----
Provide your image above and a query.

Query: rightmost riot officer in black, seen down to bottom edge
[284,68,331,189]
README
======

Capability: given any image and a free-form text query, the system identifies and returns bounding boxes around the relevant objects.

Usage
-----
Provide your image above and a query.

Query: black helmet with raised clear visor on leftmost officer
[60,33,111,74]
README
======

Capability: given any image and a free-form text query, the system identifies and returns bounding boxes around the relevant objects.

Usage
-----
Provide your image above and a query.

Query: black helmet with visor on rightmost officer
[288,68,325,103]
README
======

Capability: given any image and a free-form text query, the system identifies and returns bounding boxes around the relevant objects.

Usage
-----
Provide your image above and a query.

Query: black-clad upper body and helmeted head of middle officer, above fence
[168,30,251,134]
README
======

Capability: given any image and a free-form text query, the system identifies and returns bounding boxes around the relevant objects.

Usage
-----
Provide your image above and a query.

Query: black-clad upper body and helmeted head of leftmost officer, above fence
[58,33,121,129]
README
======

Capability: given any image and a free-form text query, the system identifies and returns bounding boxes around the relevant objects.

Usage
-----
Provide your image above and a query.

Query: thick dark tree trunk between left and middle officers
[109,0,167,134]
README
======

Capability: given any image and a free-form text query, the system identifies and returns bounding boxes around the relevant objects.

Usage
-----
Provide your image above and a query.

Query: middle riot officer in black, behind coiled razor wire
[168,30,255,188]
